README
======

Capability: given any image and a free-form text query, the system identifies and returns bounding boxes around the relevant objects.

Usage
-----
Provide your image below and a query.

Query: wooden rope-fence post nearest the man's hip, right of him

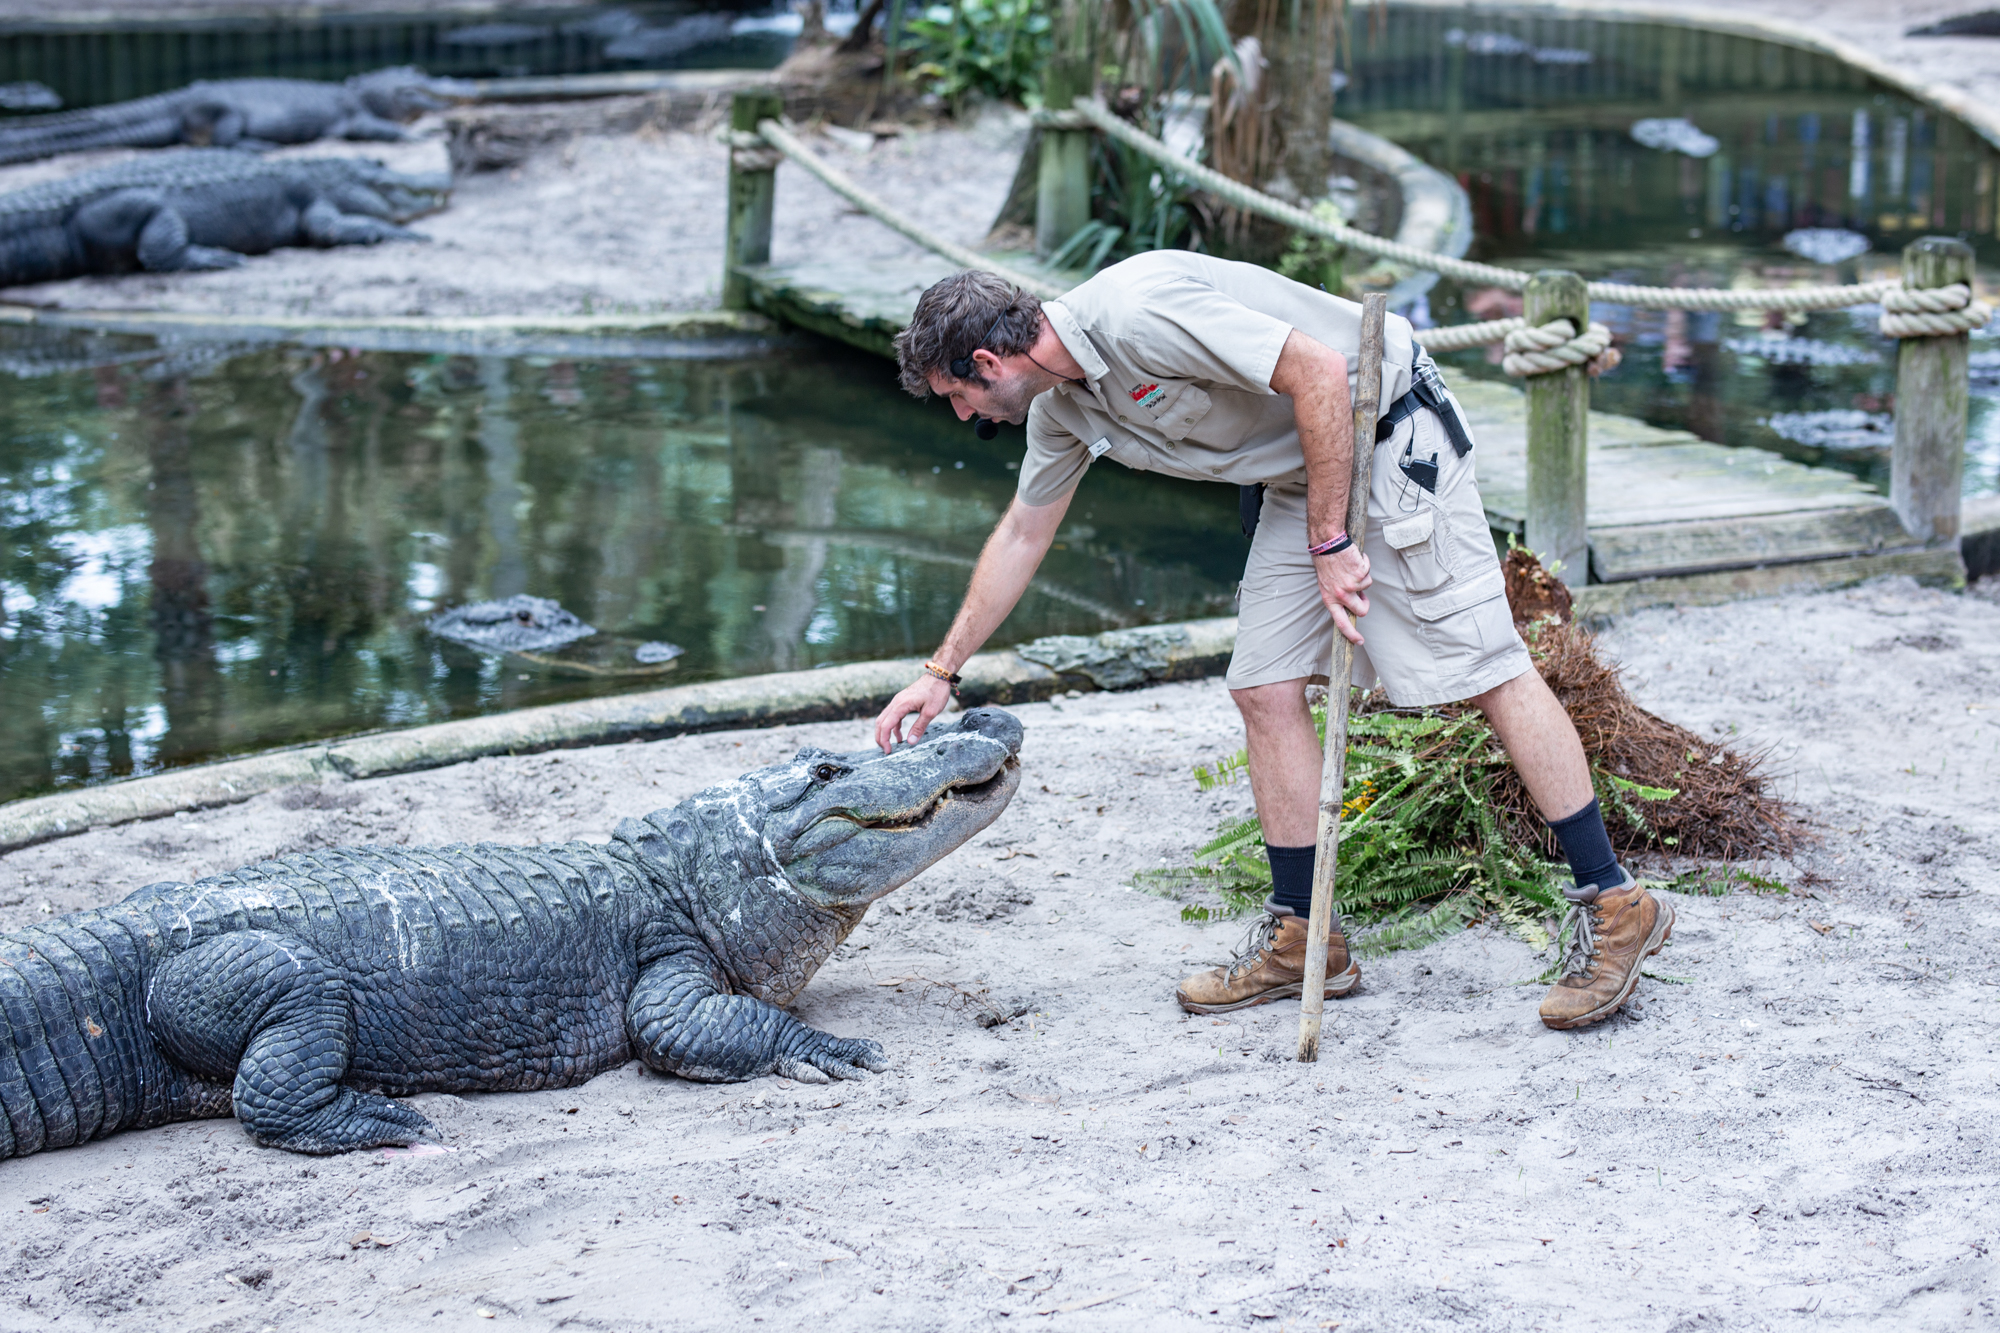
[1522,268,1590,588]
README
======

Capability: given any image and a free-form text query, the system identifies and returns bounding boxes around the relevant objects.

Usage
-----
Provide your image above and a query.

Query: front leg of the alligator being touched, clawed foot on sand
[626,959,888,1083]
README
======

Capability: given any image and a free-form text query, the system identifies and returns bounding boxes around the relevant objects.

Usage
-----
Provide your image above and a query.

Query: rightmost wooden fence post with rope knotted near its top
[1888,236,1972,546]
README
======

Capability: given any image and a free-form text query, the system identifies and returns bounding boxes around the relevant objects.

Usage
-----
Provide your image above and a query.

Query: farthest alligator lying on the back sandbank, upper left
[0,68,456,164]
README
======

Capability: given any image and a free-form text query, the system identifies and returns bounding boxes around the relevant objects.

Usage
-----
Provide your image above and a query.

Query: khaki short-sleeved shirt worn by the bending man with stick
[1016,250,1416,504]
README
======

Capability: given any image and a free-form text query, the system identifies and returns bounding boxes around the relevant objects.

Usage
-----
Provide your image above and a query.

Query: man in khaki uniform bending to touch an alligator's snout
[876,260,1674,1029]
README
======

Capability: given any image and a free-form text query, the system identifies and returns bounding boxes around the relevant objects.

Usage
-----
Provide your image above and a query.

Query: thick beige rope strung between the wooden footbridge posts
[748,100,1992,376]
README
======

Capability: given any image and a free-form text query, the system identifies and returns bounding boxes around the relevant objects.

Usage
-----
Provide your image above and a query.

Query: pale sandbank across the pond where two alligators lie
[0,108,1028,316]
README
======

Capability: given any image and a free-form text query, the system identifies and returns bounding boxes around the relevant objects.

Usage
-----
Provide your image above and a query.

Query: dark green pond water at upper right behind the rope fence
[1336,6,2000,494]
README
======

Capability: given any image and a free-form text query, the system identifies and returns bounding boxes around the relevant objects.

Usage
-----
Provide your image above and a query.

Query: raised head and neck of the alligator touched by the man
[618,709,1022,1005]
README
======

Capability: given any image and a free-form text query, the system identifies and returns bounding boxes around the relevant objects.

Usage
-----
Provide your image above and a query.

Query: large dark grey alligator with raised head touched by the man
[0,709,1022,1157]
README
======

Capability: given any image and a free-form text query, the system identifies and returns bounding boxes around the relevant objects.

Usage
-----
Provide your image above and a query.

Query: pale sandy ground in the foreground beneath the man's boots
[0,582,2000,1331]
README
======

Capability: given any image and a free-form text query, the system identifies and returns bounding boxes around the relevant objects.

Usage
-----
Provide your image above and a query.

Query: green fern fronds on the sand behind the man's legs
[1138,709,1672,955]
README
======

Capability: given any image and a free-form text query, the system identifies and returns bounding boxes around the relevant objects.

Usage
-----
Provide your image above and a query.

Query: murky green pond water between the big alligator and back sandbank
[0,338,1244,797]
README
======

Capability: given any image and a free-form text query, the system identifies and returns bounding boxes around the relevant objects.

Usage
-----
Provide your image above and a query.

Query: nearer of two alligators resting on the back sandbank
[0,148,450,286]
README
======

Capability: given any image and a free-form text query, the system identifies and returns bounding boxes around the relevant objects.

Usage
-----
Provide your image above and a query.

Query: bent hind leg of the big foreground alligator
[146,931,432,1153]
